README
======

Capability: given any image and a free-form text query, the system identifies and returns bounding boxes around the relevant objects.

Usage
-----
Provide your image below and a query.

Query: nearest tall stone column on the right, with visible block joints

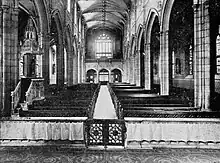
[194,0,211,111]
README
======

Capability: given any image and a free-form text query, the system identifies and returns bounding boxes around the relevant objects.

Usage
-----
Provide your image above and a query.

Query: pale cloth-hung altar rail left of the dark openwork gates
[0,119,85,143]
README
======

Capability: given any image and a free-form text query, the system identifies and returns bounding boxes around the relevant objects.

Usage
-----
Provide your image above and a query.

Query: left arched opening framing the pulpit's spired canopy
[18,8,42,78]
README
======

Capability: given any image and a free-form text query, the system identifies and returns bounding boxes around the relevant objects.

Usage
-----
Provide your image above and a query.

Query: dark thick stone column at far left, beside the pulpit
[0,1,19,116]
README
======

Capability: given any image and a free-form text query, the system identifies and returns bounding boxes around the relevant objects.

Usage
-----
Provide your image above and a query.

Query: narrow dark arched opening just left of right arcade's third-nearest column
[140,34,145,87]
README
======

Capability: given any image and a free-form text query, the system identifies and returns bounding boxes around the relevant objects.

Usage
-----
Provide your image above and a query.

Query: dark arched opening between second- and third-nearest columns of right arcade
[150,16,160,90]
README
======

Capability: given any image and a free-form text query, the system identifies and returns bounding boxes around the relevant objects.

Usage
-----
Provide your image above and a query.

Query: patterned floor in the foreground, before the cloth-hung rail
[0,146,220,163]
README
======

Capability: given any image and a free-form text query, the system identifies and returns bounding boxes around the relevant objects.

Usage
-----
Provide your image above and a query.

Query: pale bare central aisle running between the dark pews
[93,85,117,119]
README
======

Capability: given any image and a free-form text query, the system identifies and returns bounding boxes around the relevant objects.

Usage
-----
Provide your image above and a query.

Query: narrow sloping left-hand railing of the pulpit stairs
[11,81,21,115]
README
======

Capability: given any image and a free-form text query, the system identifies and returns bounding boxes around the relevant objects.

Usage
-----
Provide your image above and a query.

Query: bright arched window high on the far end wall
[95,33,112,58]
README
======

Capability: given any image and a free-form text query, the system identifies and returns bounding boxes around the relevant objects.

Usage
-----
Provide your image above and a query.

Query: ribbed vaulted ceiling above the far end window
[78,0,131,30]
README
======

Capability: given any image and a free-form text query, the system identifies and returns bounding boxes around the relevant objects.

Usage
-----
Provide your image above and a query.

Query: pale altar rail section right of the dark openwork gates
[125,118,220,149]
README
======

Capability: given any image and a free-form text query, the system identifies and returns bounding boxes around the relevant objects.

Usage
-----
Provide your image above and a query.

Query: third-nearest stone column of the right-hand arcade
[144,43,151,90]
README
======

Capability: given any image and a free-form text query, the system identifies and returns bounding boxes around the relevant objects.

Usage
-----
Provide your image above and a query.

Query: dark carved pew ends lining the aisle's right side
[107,83,123,119]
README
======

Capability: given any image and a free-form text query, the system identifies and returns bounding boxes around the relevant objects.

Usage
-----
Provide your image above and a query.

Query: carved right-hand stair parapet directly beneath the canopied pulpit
[25,79,44,105]
